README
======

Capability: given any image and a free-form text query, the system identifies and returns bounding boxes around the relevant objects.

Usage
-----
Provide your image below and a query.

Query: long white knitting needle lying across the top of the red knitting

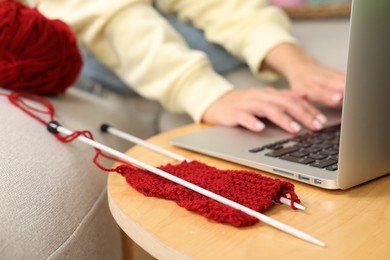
[48,121,326,247]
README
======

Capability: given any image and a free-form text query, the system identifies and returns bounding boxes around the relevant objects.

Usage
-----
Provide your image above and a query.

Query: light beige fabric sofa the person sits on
[0,19,349,260]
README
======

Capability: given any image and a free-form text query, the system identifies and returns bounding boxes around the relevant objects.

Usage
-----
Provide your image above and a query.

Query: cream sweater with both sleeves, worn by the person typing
[27,0,295,121]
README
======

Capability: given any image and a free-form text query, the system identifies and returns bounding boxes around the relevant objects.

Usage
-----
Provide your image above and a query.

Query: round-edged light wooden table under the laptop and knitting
[108,125,390,260]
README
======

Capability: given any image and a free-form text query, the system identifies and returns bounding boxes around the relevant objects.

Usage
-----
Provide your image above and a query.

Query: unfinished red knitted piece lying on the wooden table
[115,161,300,227]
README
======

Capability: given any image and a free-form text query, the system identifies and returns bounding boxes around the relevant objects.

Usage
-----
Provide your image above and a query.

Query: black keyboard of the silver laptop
[249,124,340,171]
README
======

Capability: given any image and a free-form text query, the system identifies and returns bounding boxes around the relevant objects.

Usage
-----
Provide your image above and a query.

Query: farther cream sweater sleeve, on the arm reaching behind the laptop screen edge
[157,0,296,79]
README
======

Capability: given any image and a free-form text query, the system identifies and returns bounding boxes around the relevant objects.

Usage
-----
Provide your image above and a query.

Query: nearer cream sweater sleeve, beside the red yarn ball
[30,0,233,122]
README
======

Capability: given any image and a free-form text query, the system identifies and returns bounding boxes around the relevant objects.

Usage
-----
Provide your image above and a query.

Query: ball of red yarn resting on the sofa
[0,0,82,95]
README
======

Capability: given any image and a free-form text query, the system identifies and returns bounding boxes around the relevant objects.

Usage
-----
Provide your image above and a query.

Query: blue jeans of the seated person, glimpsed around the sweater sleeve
[76,12,245,94]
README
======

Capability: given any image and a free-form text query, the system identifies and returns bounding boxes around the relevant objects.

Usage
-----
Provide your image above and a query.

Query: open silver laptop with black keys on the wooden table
[170,0,390,189]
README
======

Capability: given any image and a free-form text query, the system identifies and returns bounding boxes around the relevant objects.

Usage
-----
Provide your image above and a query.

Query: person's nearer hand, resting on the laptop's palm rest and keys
[202,87,326,134]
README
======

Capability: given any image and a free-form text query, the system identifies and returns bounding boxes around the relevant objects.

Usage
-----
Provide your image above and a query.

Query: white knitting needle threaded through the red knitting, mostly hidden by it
[100,124,306,210]
